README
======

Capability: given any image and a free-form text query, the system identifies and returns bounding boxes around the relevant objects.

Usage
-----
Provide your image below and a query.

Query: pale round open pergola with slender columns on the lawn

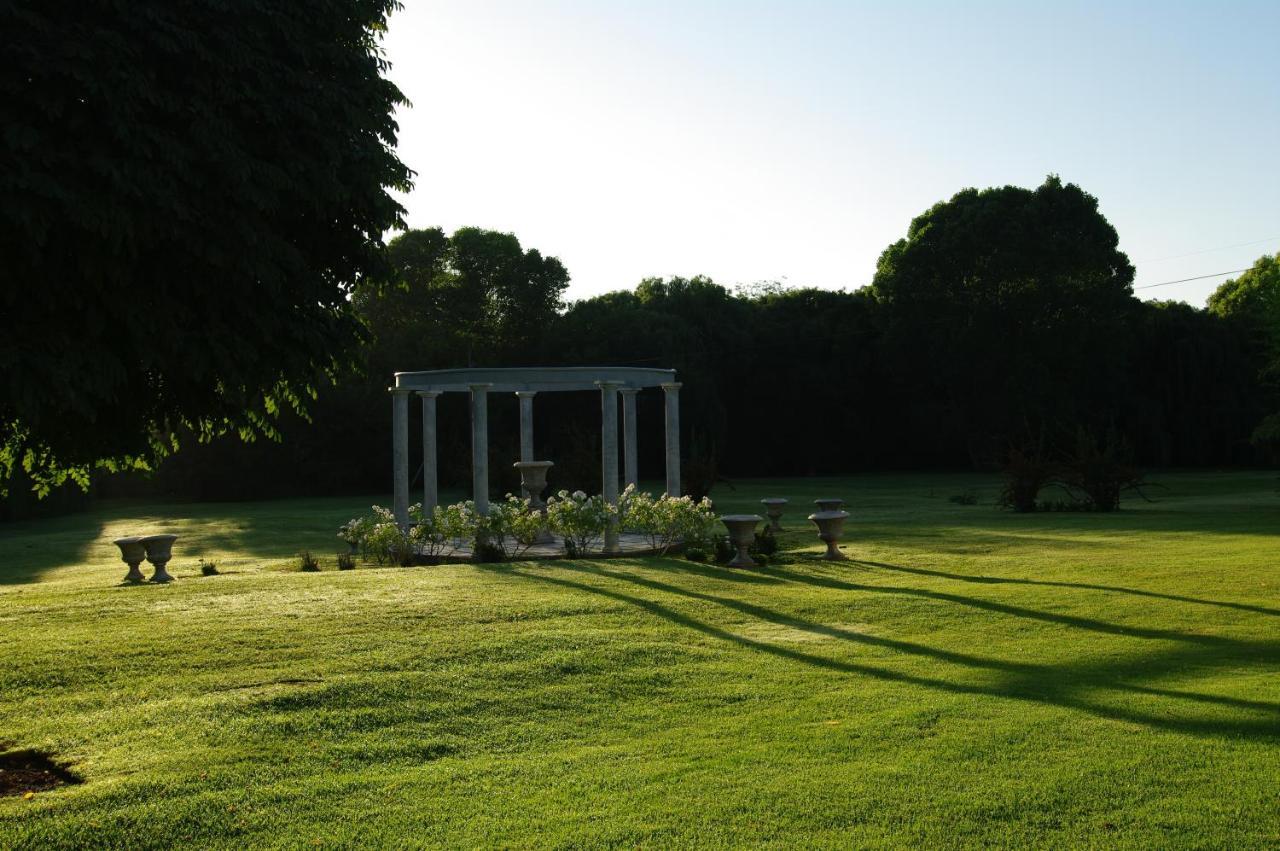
[390,366,680,547]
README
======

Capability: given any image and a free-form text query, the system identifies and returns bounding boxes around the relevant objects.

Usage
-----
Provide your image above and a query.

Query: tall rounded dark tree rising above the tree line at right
[872,175,1134,462]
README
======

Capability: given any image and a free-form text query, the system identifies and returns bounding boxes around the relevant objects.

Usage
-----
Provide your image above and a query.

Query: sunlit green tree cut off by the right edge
[1208,253,1280,447]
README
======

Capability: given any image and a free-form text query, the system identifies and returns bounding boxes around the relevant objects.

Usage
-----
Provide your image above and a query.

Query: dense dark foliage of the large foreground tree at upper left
[0,0,411,484]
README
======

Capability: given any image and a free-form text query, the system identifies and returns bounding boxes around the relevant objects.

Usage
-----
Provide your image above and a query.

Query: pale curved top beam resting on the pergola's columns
[394,366,676,393]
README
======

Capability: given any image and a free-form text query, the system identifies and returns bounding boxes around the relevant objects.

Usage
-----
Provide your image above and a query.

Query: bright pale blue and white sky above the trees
[384,0,1280,305]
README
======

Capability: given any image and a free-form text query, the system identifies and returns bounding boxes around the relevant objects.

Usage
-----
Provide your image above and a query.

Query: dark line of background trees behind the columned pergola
[15,177,1259,511]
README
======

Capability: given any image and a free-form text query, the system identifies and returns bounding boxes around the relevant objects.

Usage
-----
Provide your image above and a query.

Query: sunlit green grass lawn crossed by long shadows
[0,473,1280,848]
